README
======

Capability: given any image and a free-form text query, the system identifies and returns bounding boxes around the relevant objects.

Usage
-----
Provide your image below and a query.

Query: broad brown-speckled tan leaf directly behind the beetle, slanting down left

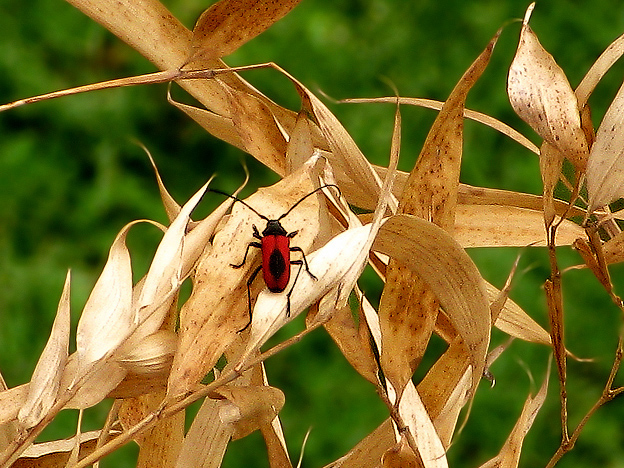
[169,158,329,397]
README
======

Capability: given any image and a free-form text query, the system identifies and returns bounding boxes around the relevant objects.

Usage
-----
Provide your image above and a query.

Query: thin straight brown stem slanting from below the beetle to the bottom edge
[71,322,323,468]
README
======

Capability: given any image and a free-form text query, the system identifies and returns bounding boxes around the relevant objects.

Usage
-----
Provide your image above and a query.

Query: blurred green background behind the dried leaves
[0,0,624,467]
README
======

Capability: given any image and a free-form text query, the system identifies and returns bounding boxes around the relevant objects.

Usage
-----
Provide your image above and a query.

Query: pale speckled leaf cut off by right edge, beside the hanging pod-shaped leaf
[587,78,624,212]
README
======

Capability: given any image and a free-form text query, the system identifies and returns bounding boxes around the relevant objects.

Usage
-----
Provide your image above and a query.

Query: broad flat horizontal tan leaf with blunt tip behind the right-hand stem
[453,205,585,248]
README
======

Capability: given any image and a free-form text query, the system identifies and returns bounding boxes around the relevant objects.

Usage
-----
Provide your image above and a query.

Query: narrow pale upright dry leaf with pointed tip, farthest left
[17,272,71,429]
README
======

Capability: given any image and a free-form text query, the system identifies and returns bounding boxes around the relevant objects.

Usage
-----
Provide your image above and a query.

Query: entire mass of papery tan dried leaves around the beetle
[6,0,624,468]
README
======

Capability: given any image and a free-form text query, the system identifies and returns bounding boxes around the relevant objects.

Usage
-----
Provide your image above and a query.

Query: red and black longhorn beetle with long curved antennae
[210,184,340,331]
